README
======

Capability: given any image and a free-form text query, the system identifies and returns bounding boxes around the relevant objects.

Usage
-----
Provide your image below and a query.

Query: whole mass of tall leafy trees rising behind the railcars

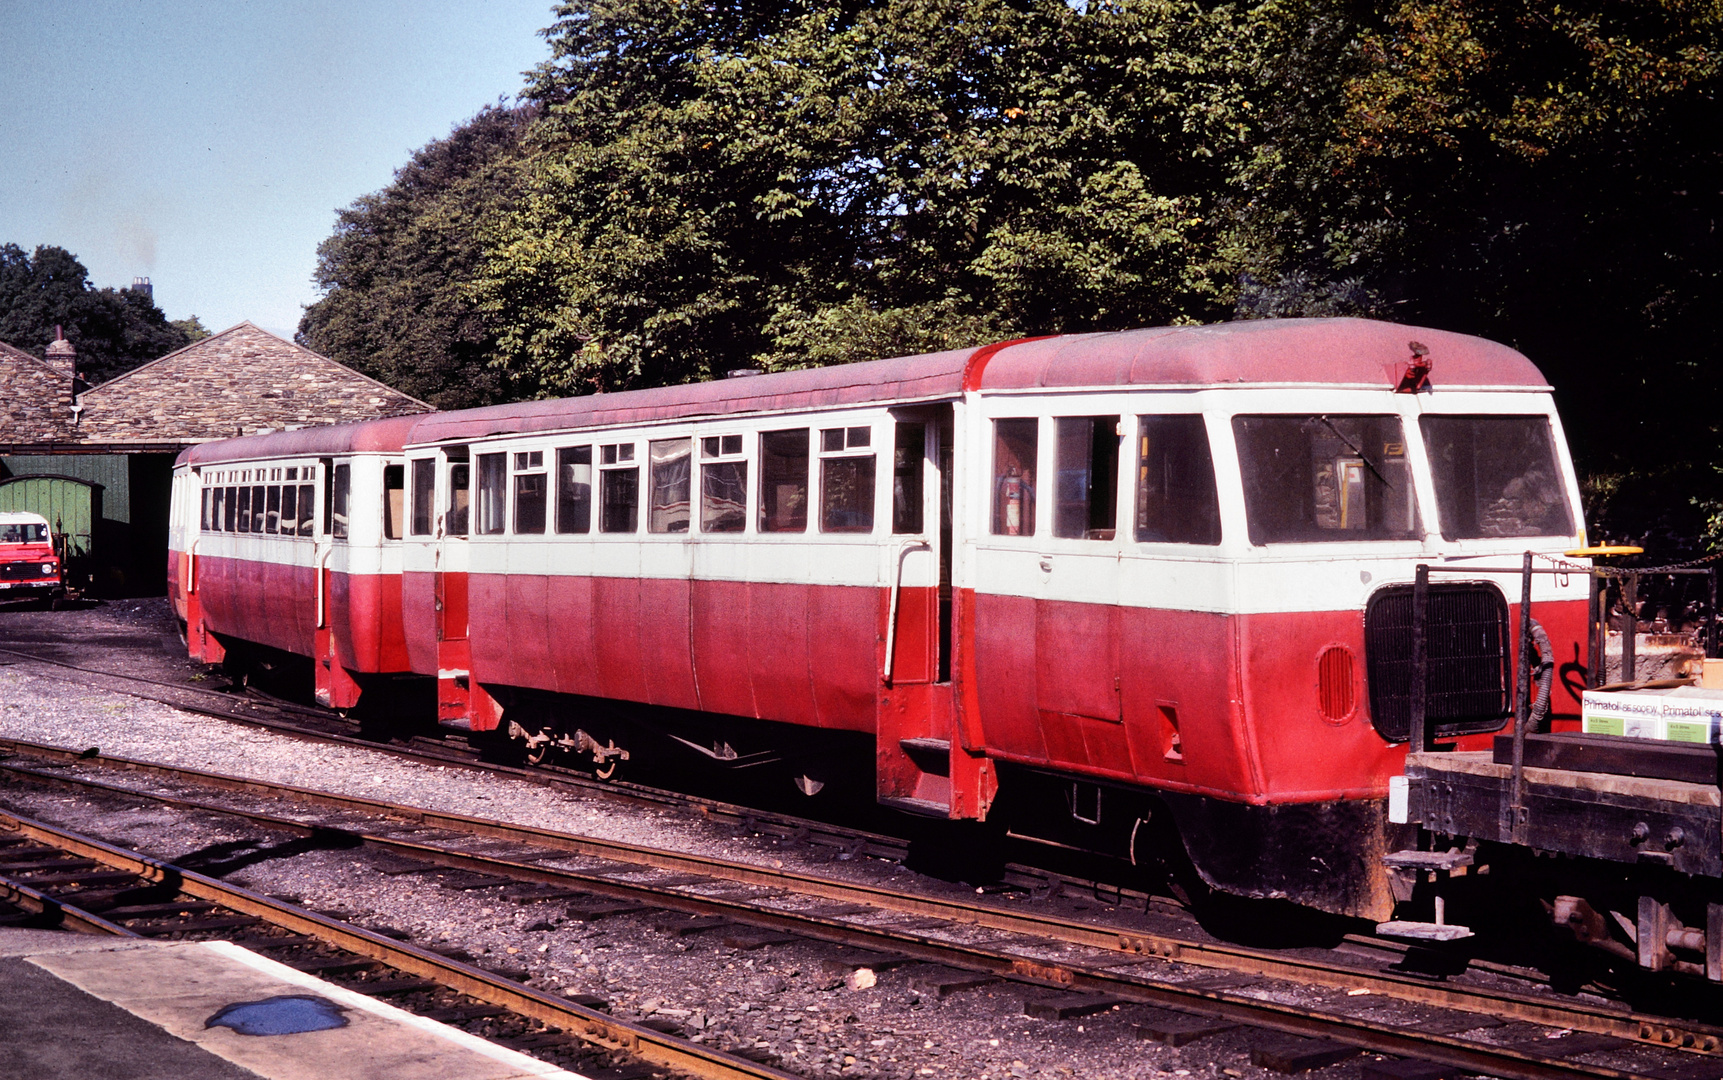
[302,0,1723,554]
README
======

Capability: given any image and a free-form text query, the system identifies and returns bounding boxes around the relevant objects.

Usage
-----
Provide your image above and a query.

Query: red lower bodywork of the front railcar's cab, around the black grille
[961,594,1585,803]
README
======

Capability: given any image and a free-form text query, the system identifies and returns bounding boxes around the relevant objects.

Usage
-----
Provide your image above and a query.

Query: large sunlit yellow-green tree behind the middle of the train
[474,0,1244,393]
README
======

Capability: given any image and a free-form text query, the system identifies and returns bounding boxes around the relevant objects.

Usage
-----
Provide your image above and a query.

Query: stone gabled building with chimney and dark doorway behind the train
[0,322,431,596]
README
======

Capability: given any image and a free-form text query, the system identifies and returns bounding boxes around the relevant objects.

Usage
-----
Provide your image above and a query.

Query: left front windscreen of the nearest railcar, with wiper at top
[1232,415,1418,544]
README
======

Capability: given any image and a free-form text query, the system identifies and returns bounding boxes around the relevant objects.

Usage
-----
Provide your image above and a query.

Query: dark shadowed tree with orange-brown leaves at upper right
[1237,0,1723,501]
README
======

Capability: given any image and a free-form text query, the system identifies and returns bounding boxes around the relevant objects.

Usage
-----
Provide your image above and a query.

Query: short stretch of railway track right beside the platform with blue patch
[0,811,794,1080]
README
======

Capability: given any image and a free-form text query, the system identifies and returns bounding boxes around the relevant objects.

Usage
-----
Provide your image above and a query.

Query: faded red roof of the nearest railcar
[408,319,1547,443]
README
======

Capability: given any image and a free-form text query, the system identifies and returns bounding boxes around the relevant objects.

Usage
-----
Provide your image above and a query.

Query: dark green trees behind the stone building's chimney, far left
[0,245,190,386]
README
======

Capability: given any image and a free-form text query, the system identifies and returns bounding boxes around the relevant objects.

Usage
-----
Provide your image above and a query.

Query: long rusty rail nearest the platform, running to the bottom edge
[0,810,803,1080]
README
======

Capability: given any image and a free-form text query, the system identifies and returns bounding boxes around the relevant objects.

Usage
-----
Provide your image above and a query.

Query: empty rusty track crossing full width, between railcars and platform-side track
[0,741,1723,1080]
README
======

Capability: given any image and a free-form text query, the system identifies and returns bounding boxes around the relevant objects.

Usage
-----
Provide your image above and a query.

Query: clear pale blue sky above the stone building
[0,0,551,336]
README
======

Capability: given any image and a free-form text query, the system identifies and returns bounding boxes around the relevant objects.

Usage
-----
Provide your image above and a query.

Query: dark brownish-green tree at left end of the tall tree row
[298,107,532,408]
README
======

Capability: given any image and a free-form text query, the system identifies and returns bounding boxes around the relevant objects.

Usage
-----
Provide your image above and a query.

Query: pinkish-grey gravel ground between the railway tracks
[0,601,1426,1080]
